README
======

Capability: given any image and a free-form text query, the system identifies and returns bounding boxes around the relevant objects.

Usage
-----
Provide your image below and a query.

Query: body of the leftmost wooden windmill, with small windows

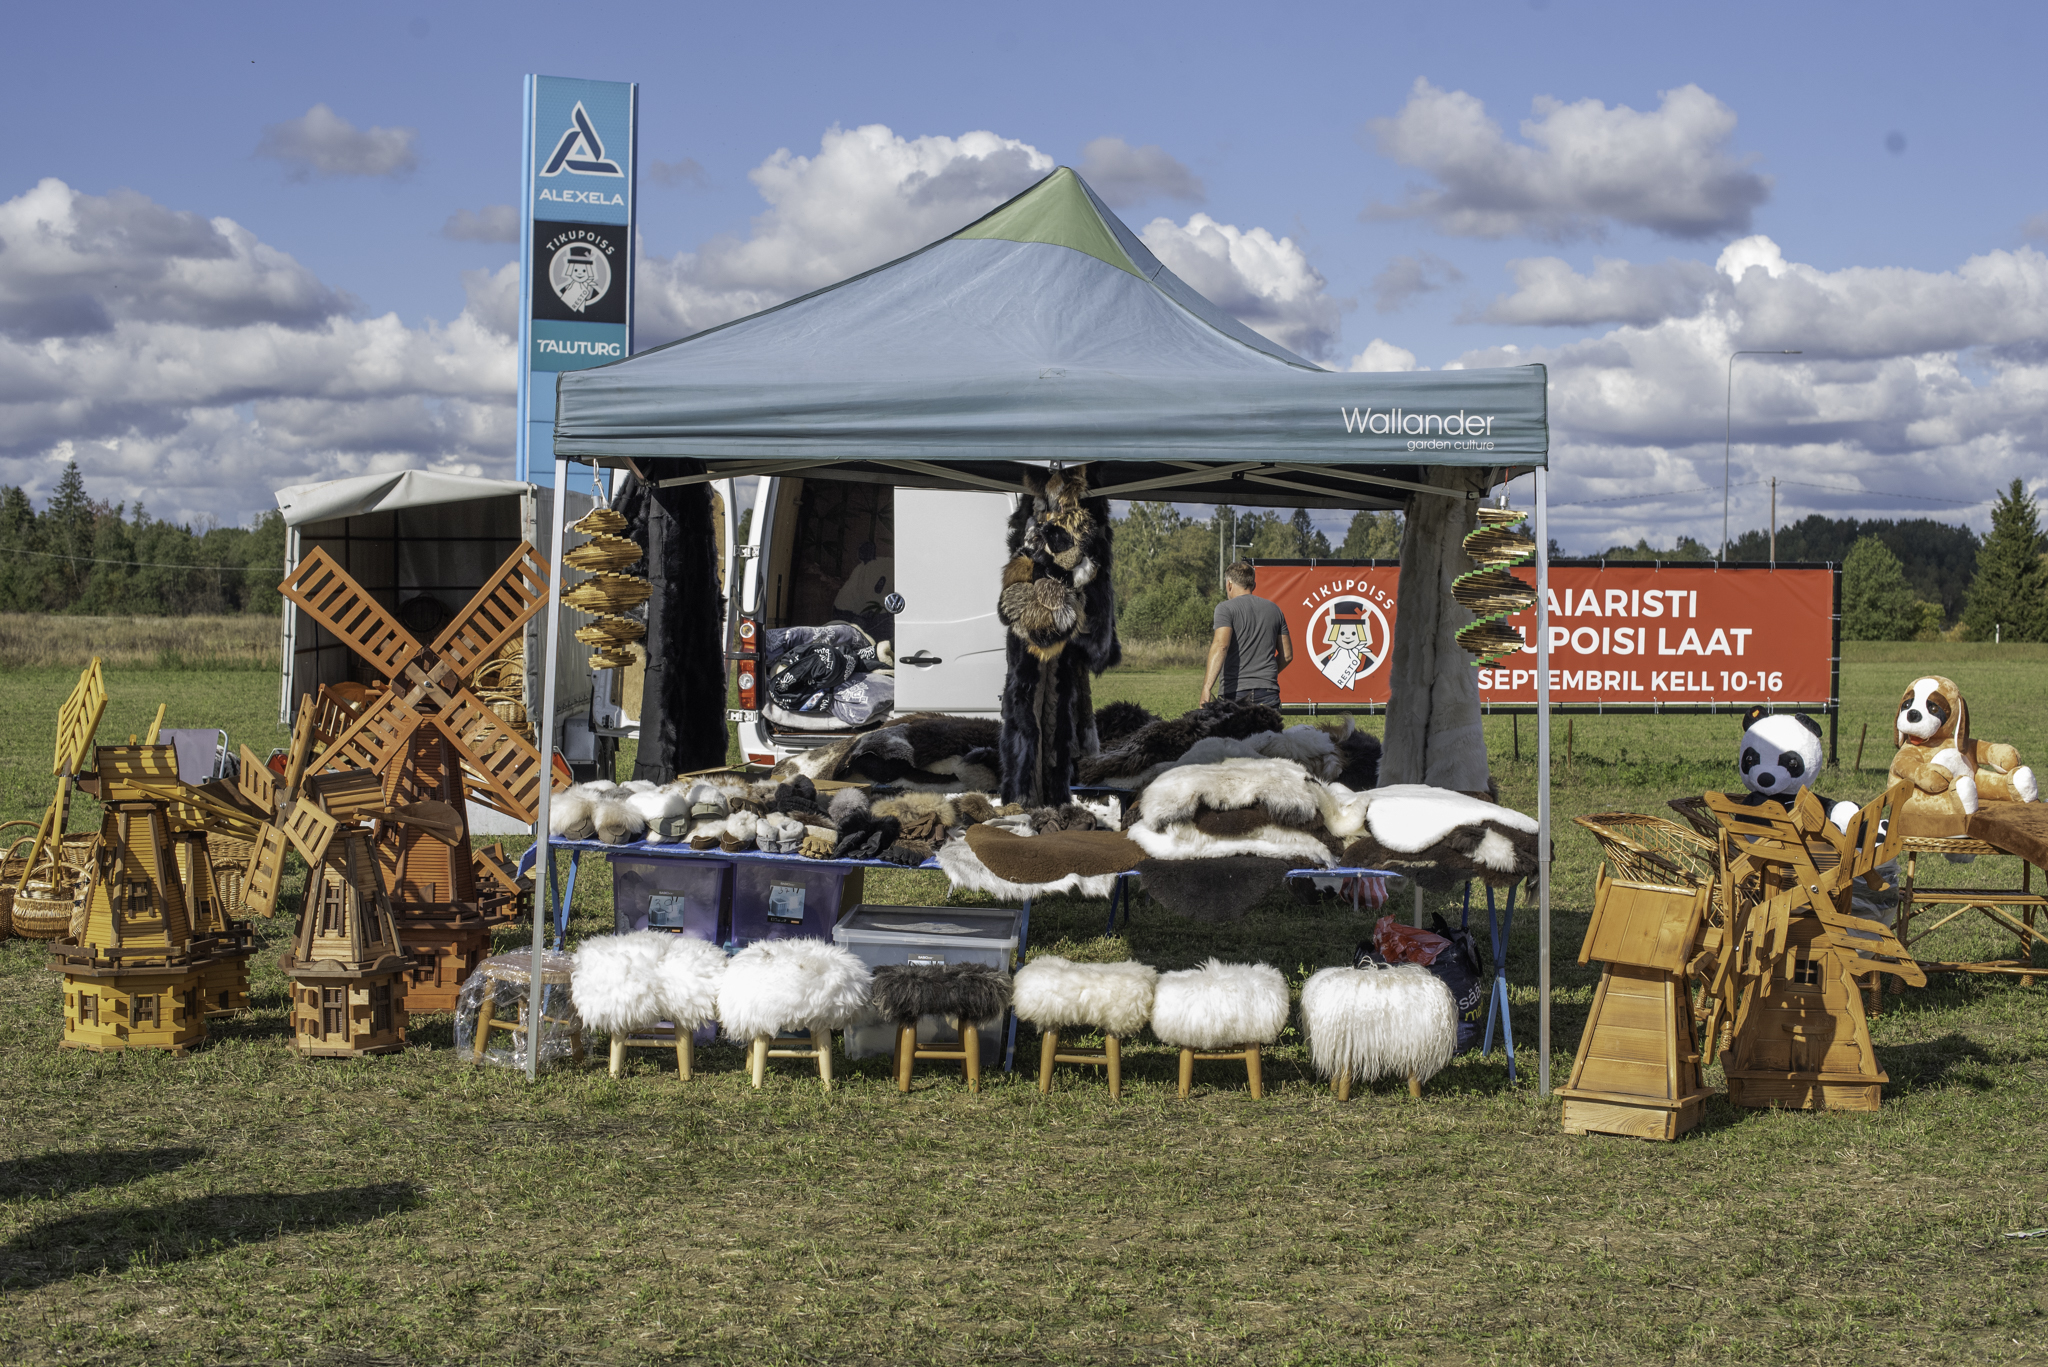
[51,746,213,1053]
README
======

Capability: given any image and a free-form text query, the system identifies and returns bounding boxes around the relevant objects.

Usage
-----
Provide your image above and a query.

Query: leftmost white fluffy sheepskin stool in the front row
[569,930,725,1082]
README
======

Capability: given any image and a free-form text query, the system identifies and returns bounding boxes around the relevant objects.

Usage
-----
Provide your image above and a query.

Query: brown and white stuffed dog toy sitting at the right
[1892,674,2040,836]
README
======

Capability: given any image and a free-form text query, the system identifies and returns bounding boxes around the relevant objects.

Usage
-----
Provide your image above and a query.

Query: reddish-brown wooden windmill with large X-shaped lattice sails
[279,543,549,1010]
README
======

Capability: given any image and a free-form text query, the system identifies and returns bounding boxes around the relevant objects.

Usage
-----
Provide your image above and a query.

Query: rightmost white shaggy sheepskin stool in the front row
[1300,963,1458,1101]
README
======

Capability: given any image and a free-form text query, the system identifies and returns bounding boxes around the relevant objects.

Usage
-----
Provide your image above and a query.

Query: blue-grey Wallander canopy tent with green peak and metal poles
[535,166,1550,1090]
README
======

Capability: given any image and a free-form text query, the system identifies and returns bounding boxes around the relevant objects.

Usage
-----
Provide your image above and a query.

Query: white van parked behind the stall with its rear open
[731,478,1020,764]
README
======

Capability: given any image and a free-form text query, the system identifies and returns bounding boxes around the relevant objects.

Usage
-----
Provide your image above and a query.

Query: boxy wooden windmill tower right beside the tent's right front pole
[1559,816,1714,1140]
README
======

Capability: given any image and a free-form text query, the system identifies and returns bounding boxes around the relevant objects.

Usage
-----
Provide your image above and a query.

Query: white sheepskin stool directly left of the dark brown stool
[719,941,872,1092]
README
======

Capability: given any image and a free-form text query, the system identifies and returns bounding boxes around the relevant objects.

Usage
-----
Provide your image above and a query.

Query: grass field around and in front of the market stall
[0,646,2048,1365]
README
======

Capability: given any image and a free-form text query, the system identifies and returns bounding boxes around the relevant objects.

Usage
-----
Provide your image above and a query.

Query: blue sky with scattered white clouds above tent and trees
[0,0,2048,549]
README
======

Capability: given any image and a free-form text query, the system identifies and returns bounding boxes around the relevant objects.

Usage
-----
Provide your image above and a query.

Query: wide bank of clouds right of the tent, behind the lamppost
[1458,238,2048,549]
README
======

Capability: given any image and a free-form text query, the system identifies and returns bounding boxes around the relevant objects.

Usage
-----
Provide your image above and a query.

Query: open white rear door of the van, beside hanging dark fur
[895,488,1012,717]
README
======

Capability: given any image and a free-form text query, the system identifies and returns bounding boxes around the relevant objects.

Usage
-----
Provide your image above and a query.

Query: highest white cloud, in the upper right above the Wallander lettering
[1366,80,1772,240]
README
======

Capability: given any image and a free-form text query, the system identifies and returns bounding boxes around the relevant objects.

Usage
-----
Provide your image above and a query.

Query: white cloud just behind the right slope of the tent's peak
[1139,213,1346,357]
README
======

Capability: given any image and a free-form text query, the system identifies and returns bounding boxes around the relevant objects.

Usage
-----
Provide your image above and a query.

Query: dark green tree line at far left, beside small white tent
[0,463,285,617]
